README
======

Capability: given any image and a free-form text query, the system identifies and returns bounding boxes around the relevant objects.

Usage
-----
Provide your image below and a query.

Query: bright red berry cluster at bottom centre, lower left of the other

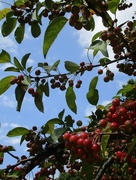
[63,132,100,163]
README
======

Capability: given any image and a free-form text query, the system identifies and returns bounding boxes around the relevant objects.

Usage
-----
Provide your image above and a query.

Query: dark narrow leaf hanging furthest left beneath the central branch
[15,85,26,112]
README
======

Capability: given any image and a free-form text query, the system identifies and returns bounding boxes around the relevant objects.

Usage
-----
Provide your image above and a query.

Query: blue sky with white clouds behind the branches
[0,0,136,177]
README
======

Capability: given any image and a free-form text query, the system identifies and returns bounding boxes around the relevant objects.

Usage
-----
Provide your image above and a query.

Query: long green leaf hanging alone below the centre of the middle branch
[65,87,77,114]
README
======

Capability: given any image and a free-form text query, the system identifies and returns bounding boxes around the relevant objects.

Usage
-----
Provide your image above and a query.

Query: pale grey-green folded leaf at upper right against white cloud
[89,40,109,57]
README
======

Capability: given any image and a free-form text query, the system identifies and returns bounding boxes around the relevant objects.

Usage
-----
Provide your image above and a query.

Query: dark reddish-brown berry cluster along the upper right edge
[101,21,136,76]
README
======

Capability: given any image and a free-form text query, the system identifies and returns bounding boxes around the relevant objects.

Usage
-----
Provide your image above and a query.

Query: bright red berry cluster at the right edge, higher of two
[98,99,136,134]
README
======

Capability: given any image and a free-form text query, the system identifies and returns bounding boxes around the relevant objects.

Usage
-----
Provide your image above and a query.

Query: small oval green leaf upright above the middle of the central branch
[65,61,79,72]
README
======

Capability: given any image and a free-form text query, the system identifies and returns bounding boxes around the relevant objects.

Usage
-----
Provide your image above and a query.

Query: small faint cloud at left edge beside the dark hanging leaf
[0,95,16,108]
